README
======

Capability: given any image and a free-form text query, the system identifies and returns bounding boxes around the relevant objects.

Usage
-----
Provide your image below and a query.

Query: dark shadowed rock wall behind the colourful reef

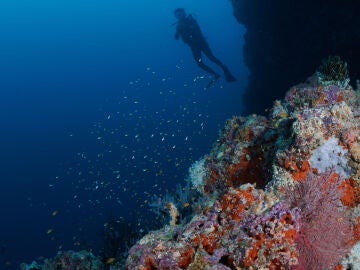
[231,0,360,114]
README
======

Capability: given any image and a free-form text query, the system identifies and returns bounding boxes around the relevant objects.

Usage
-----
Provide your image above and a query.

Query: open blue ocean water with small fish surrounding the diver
[0,0,248,269]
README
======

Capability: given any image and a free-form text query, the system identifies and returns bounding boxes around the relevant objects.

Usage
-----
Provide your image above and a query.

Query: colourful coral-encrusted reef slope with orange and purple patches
[126,70,360,270]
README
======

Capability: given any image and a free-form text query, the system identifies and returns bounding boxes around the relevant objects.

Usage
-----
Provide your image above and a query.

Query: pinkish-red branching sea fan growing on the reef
[285,172,353,270]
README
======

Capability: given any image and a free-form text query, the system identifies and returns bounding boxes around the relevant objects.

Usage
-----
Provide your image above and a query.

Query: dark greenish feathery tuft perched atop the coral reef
[317,56,350,88]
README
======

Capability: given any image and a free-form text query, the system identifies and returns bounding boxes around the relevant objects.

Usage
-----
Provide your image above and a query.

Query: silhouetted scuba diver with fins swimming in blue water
[174,8,236,86]
